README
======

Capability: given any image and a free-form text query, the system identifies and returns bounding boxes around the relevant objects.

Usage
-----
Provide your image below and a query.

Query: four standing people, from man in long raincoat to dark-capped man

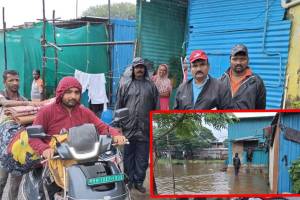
[116,44,266,192]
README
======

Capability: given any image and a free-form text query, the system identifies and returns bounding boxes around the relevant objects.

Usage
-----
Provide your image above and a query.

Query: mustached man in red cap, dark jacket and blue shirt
[174,50,232,110]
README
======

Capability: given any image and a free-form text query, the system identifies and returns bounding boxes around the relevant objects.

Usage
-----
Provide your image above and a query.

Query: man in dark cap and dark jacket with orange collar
[221,44,266,109]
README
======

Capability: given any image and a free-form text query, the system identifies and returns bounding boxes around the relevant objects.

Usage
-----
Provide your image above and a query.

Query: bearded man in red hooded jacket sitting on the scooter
[29,77,127,196]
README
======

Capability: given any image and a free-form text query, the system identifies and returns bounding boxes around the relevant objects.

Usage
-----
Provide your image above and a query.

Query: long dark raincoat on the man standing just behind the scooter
[115,63,159,142]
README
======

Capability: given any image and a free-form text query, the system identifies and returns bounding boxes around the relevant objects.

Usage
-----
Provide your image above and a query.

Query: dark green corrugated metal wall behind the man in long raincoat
[137,0,187,78]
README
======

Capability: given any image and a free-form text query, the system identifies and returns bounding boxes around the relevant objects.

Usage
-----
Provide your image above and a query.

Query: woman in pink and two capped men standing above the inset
[153,44,266,110]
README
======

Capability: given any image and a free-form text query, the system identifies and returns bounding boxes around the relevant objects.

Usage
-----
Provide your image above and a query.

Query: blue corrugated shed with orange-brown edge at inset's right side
[265,113,300,193]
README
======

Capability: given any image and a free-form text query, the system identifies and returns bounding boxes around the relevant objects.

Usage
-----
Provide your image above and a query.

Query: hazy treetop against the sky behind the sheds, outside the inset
[82,3,136,19]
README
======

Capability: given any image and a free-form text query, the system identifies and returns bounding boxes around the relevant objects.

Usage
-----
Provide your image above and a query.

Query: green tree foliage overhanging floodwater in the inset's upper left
[153,113,236,150]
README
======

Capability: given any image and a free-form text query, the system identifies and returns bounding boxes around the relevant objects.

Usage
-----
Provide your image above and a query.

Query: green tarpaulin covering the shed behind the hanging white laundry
[0,23,109,98]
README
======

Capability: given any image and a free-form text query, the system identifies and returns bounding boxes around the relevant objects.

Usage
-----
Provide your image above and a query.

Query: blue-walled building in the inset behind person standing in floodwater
[228,113,275,173]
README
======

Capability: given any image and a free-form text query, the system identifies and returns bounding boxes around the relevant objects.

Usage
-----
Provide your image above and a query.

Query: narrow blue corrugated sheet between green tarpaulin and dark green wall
[112,19,136,102]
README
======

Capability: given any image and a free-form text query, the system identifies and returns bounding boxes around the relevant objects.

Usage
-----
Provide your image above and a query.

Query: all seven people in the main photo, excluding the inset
[0,45,266,199]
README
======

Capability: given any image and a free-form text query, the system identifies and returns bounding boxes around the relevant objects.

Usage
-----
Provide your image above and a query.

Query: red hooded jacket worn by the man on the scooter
[29,77,120,154]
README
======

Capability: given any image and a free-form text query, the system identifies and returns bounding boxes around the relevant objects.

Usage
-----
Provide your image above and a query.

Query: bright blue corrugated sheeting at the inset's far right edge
[278,113,300,193]
